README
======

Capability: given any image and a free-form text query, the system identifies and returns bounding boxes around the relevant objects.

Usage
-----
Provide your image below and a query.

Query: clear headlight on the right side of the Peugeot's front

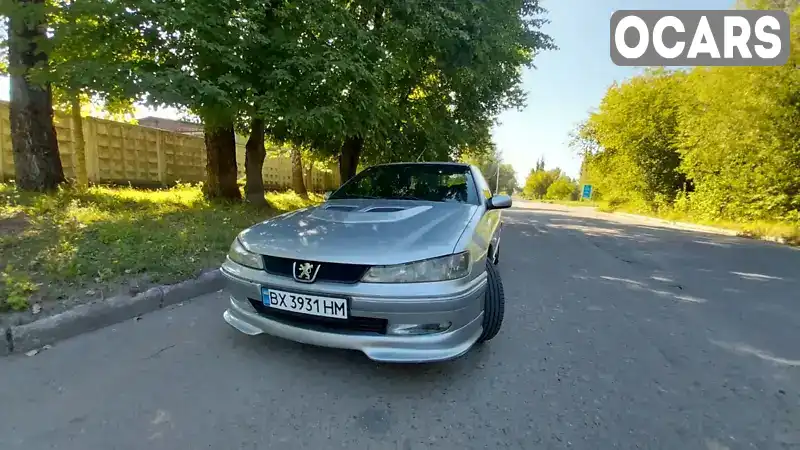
[361,252,470,283]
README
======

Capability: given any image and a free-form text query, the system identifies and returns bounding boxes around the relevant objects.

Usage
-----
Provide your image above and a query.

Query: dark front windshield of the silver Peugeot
[330,164,479,205]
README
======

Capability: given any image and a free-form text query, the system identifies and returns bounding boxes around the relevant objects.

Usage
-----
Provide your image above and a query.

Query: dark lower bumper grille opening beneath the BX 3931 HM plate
[248,298,389,334]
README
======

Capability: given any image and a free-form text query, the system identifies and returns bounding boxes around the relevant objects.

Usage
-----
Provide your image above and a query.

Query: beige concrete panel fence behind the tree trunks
[0,101,339,191]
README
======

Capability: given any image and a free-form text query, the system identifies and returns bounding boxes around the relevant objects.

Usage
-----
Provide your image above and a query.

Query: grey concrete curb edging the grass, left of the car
[0,269,224,356]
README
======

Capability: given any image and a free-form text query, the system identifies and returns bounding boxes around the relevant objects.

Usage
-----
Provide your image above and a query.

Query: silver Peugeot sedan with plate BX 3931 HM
[222,163,511,362]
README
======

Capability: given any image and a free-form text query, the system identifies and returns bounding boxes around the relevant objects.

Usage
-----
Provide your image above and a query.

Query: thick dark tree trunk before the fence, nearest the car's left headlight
[203,121,242,200]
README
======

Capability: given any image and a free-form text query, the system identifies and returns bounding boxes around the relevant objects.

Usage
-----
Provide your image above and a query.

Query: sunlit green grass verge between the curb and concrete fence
[0,183,321,311]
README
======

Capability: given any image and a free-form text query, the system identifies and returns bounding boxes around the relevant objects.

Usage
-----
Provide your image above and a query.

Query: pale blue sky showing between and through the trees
[0,0,735,184]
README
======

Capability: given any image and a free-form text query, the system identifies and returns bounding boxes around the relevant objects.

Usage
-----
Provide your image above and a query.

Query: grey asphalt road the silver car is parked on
[0,205,800,450]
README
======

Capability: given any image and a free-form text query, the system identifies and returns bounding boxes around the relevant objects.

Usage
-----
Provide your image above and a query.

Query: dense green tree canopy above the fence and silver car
[1,0,555,197]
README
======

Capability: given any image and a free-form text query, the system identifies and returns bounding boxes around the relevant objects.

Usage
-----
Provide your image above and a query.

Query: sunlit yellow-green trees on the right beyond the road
[573,1,800,220]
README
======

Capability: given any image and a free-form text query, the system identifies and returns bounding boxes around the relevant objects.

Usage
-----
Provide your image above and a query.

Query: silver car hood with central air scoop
[239,199,477,265]
